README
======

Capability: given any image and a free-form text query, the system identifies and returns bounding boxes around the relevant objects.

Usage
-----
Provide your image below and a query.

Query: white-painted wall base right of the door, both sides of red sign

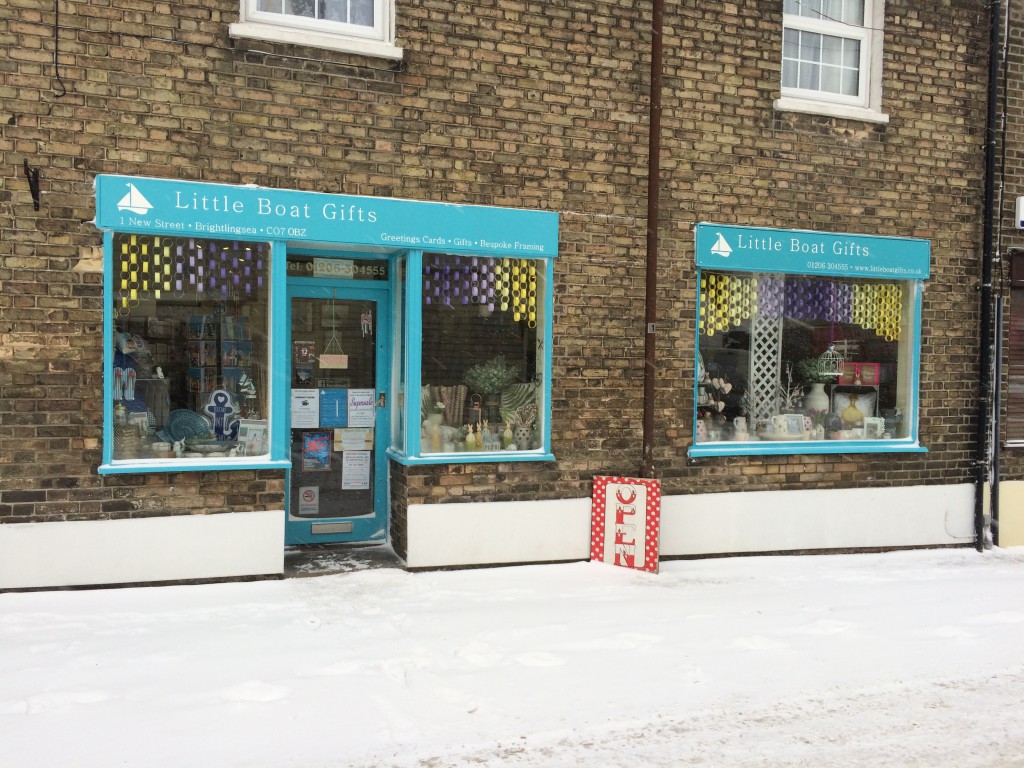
[407,483,974,568]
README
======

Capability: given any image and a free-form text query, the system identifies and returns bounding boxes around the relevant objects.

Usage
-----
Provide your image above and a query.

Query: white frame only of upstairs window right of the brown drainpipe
[774,0,889,123]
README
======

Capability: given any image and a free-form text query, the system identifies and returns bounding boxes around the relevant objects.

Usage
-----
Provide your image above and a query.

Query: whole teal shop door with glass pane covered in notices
[285,280,390,545]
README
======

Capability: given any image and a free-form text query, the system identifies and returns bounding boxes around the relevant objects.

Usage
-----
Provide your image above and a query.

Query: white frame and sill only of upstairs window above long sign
[228,0,403,60]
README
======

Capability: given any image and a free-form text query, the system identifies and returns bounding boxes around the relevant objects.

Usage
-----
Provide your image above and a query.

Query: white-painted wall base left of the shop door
[0,510,285,589]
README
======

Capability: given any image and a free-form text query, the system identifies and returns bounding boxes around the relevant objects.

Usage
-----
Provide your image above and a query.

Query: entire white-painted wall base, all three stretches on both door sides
[0,484,974,589]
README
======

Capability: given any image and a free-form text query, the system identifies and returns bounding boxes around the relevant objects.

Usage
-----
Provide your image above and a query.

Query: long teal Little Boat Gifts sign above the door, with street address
[95,174,558,257]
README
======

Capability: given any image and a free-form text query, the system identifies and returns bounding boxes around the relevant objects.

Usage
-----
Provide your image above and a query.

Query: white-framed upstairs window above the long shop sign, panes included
[229,0,402,59]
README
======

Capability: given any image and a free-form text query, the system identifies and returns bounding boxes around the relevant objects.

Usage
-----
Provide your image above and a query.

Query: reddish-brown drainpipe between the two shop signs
[640,0,665,477]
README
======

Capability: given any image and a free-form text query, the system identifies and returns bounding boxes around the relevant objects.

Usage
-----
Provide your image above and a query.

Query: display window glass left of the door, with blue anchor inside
[104,233,270,469]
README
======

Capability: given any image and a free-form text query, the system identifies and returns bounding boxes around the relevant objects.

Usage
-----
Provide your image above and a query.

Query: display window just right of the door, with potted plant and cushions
[393,253,550,462]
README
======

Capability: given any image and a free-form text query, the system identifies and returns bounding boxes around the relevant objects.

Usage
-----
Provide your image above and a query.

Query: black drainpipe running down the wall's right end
[974,0,1001,552]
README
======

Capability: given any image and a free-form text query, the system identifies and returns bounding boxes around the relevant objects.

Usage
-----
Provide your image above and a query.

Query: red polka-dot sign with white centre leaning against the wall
[590,477,662,573]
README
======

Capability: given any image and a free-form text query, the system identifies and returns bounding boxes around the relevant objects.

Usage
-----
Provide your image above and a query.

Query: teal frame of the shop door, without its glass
[281,278,391,545]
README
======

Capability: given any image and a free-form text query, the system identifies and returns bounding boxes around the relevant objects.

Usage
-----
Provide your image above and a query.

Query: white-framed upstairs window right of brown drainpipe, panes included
[775,0,888,122]
